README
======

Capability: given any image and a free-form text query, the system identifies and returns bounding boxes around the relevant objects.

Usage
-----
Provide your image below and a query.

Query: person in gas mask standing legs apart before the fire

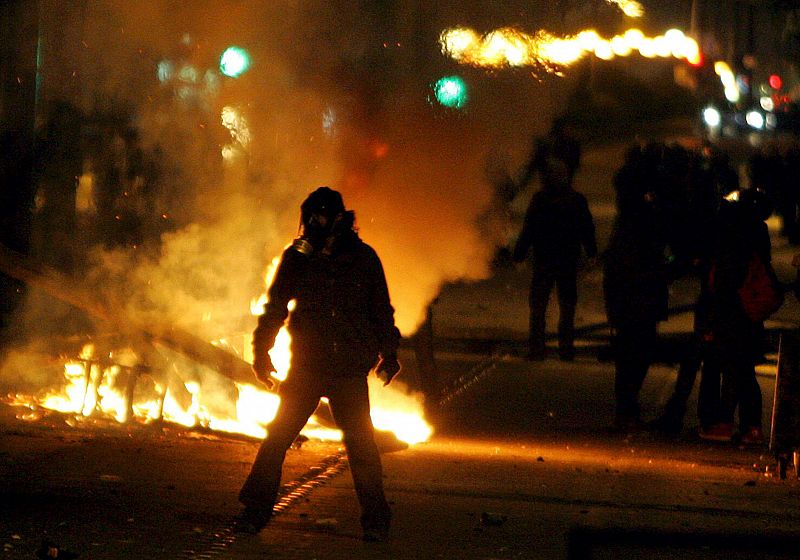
[237,187,400,541]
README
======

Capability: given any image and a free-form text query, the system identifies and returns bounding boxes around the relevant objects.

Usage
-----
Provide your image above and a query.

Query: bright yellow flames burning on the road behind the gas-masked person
[4,335,432,444]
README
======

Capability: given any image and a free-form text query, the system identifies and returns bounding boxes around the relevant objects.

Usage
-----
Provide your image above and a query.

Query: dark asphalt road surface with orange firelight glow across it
[0,354,800,559]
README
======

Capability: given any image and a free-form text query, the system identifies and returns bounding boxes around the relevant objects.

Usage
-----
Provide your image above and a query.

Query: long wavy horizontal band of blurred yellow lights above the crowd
[439,27,700,75]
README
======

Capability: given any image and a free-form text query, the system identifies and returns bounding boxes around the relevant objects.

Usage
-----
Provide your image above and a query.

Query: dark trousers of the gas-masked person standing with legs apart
[239,371,391,529]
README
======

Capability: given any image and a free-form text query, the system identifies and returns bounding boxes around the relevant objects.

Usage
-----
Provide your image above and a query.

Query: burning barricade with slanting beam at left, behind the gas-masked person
[0,241,432,444]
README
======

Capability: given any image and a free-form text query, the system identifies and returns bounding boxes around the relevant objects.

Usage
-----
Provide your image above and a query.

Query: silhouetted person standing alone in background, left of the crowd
[513,129,597,360]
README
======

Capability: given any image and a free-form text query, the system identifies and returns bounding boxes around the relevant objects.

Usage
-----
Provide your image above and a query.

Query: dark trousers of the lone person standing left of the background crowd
[528,261,578,356]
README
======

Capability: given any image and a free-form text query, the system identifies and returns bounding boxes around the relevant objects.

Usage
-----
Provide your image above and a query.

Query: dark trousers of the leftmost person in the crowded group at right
[613,320,657,420]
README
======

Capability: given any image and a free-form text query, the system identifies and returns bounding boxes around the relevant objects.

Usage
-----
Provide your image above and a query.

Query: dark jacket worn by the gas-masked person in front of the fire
[253,230,400,375]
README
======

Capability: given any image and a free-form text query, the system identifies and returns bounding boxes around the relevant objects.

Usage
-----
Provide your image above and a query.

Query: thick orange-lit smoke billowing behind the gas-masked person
[48,2,506,337]
